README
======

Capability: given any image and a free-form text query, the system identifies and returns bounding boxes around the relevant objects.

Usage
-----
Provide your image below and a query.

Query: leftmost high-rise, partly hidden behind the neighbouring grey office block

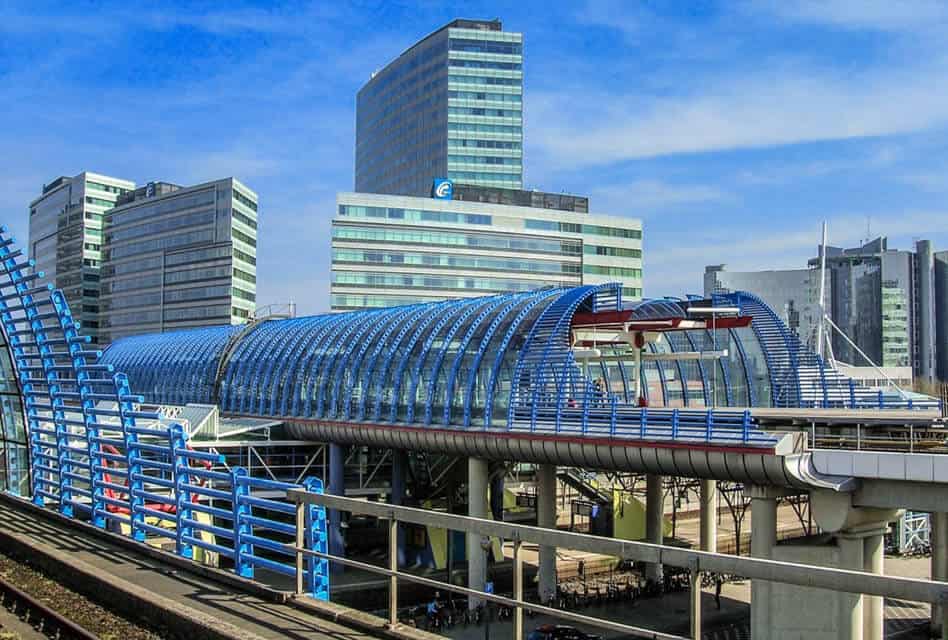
[29,171,135,341]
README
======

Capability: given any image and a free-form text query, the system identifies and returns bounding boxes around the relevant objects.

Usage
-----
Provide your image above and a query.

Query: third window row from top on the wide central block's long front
[332,249,580,275]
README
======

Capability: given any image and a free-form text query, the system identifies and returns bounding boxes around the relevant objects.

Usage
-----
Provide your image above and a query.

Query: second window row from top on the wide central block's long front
[332,226,582,256]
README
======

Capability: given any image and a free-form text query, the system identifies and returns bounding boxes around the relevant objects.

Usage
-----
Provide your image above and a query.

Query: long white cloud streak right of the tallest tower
[528,53,948,166]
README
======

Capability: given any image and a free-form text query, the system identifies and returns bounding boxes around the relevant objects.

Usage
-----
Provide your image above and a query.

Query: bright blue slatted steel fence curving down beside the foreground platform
[0,227,329,600]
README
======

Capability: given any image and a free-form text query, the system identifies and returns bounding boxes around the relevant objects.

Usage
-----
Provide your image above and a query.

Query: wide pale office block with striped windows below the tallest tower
[331,193,642,311]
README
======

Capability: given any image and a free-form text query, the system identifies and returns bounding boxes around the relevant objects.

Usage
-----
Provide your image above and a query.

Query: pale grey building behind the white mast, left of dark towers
[704,264,832,349]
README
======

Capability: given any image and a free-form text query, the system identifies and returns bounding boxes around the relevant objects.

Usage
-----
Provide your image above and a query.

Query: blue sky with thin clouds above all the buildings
[0,0,948,313]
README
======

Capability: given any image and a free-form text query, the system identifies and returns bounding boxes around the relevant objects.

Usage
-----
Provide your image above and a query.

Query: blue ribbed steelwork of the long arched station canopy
[96,284,940,448]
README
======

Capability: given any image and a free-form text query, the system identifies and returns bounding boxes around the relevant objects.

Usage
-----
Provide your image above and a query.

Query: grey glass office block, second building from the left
[101,178,257,343]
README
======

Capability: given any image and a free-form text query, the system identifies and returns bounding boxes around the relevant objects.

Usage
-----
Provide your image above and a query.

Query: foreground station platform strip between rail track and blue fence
[0,495,431,640]
